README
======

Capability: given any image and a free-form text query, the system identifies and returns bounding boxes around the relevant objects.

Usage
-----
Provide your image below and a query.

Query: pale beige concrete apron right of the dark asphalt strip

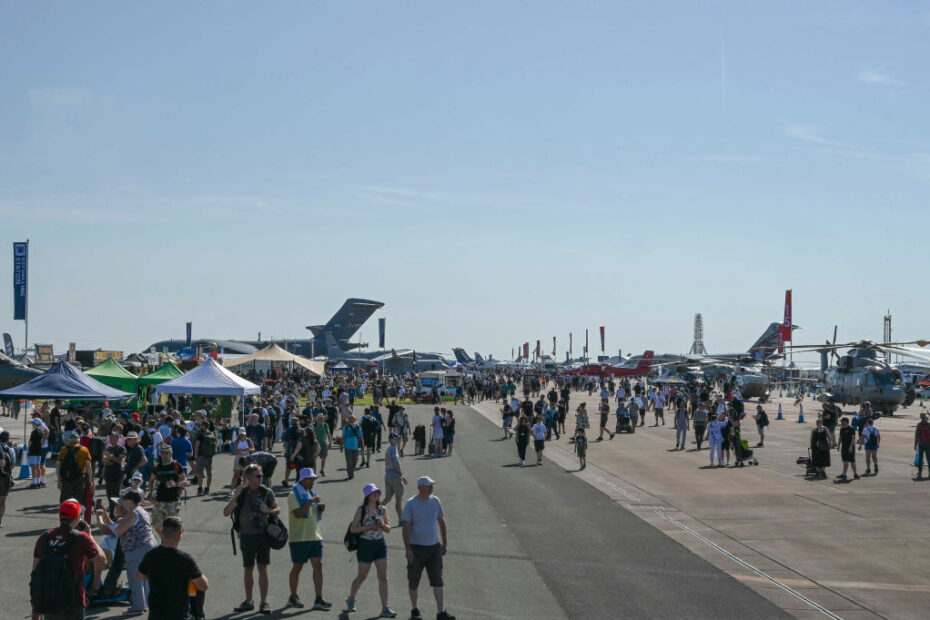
[477,392,930,619]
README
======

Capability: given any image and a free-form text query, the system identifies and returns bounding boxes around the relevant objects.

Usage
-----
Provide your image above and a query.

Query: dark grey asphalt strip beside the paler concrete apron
[0,407,790,619]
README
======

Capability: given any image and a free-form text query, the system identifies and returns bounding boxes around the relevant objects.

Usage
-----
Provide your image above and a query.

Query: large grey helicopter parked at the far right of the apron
[785,328,930,415]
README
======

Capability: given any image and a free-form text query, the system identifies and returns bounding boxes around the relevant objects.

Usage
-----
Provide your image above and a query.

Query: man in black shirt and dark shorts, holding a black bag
[223,463,280,614]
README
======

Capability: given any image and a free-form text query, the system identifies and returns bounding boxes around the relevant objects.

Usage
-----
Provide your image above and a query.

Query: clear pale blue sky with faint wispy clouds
[0,0,930,358]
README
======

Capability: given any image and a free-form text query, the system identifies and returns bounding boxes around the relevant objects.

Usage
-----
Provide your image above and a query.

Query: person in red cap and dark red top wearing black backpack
[29,499,106,620]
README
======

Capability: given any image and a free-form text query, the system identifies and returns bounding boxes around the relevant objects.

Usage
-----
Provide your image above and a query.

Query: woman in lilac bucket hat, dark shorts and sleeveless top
[346,483,397,618]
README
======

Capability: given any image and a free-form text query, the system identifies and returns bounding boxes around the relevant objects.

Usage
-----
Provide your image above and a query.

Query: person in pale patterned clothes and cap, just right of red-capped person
[97,490,156,614]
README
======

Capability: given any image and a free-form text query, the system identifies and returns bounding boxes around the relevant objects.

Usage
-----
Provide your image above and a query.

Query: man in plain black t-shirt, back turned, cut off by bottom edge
[136,517,209,620]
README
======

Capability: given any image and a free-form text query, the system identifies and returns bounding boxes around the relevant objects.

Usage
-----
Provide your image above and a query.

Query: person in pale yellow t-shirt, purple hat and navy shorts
[287,467,332,611]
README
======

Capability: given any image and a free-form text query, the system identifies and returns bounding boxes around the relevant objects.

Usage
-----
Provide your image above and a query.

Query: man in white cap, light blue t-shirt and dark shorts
[401,476,455,620]
